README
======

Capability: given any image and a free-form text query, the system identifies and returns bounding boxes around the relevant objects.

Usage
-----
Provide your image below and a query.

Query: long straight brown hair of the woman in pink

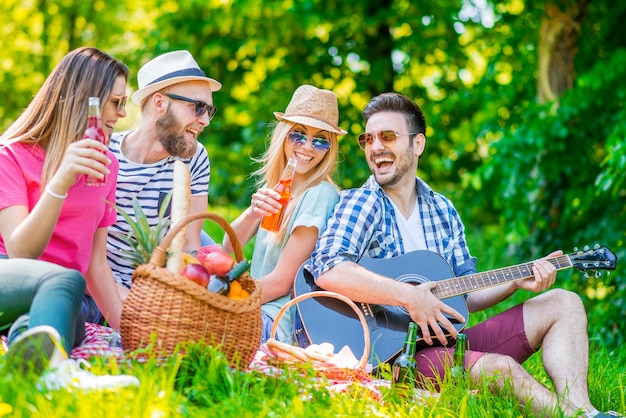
[0,47,128,187]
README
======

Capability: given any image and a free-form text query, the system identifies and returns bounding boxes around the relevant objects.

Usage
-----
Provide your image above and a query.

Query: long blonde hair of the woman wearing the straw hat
[252,121,339,242]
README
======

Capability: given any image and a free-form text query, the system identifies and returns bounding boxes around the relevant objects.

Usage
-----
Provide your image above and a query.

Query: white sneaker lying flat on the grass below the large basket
[37,359,139,391]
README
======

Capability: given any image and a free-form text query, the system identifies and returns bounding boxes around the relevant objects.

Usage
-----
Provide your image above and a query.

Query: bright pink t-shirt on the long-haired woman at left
[0,143,118,274]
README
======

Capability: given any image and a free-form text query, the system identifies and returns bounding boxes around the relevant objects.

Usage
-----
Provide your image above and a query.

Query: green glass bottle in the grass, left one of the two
[391,322,417,399]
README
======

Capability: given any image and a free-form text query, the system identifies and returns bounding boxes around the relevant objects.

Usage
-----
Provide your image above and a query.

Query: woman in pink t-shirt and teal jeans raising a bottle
[0,47,128,378]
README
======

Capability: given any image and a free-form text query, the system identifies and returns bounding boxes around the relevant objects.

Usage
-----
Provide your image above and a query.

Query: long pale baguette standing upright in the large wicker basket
[166,160,191,274]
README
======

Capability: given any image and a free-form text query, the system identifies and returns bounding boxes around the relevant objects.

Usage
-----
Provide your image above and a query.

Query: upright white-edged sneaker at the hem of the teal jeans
[7,325,67,376]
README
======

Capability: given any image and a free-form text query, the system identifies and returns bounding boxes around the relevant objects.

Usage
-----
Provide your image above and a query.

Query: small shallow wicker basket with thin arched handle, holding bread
[266,290,370,380]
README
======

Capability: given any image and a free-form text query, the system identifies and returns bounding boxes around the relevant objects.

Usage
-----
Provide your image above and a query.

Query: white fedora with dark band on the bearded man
[131,50,222,105]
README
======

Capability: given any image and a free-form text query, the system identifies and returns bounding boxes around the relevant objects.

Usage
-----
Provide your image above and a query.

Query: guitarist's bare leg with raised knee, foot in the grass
[524,289,595,413]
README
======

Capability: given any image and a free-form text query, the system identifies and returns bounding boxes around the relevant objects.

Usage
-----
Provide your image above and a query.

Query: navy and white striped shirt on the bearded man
[107,131,211,287]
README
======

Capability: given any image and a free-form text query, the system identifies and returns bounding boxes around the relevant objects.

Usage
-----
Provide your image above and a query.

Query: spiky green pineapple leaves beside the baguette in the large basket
[115,193,172,268]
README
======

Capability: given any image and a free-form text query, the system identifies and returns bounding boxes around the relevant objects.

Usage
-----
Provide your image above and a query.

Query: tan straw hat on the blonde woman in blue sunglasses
[274,84,348,135]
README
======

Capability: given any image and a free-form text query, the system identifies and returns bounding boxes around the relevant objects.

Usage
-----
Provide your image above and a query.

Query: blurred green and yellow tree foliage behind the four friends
[0,0,626,344]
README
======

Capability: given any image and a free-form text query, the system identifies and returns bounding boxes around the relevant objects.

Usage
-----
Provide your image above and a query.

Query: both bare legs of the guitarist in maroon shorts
[470,289,595,416]
